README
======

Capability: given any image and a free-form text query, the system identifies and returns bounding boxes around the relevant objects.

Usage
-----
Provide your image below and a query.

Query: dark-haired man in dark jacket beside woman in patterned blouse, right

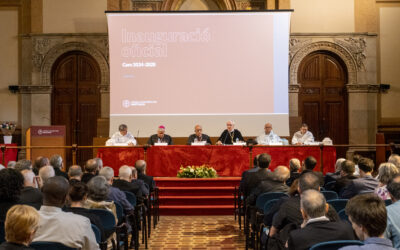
[341,158,379,199]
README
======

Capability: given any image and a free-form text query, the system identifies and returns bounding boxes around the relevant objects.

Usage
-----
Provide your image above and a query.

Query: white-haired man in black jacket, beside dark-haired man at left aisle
[112,165,143,203]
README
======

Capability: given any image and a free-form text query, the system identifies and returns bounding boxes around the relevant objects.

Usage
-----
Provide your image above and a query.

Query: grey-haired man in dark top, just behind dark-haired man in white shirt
[19,169,43,210]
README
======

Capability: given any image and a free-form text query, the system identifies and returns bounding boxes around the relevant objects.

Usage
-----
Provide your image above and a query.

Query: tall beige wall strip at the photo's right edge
[379,7,400,119]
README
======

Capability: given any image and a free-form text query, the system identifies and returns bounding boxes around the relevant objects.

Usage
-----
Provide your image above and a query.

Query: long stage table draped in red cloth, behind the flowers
[97,145,336,177]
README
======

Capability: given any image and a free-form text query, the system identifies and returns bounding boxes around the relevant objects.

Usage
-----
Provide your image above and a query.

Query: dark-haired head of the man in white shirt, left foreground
[42,177,69,207]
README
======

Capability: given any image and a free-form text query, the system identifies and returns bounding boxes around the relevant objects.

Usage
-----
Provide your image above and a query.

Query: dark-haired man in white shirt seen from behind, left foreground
[33,176,98,250]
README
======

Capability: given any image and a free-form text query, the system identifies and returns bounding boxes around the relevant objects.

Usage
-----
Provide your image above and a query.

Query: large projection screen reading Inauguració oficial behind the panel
[107,11,291,137]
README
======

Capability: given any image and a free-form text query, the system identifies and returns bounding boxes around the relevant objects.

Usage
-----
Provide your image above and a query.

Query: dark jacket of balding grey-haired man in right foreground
[288,221,356,250]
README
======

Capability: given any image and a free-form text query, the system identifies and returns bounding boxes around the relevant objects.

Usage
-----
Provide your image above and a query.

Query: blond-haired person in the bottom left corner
[0,205,39,250]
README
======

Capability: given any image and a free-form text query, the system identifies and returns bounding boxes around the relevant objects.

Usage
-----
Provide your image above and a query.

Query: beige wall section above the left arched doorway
[43,0,107,33]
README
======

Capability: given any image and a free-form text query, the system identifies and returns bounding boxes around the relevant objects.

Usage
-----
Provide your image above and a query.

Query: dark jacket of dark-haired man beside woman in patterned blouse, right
[341,175,379,199]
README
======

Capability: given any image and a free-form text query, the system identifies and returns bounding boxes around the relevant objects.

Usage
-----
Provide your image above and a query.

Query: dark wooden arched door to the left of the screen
[51,51,101,166]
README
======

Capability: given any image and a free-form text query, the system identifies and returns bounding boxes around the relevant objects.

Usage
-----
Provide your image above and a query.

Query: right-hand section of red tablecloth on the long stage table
[252,146,336,174]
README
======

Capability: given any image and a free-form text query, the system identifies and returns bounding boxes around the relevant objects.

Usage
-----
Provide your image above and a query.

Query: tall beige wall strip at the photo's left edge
[0,8,19,122]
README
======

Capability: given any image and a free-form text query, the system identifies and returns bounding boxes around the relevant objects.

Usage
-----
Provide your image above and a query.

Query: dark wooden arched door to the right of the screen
[298,51,348,155]
